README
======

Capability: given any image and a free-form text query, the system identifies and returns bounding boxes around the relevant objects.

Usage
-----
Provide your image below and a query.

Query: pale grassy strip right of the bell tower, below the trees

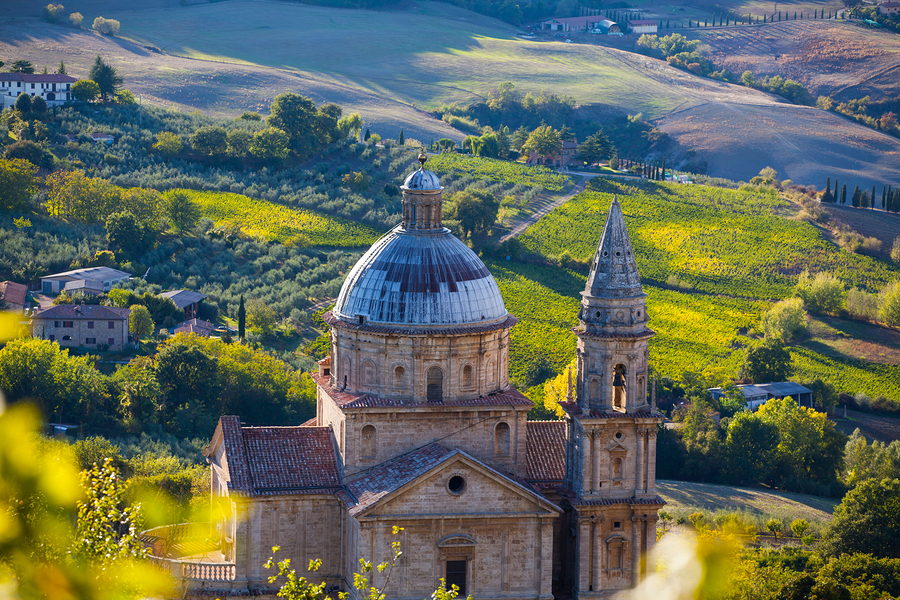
[656,481,836,523]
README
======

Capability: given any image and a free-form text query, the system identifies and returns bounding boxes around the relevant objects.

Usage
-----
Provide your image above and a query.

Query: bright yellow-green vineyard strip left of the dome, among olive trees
[182,190,378,247]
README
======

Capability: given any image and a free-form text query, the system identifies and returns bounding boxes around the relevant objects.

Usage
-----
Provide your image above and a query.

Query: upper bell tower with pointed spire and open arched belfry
[575,196,654,412]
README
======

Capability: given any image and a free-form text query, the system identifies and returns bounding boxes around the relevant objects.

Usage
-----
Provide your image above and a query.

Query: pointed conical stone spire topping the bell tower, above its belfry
[584,196,644,298]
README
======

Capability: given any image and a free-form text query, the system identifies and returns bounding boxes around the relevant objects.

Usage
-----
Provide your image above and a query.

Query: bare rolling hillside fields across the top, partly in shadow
[0,0,900,185]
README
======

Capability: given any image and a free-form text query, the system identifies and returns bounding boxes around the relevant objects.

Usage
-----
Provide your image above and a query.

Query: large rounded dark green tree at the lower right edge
[819,479,900,558]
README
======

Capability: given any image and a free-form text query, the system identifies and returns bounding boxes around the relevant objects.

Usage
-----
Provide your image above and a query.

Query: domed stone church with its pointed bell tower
[198,155,664,600]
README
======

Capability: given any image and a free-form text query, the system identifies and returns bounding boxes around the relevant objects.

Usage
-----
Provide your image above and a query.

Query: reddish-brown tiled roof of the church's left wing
[220,416,341,496]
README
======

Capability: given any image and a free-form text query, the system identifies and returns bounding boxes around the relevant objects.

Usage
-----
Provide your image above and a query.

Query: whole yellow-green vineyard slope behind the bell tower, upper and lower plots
[496,178,900,400]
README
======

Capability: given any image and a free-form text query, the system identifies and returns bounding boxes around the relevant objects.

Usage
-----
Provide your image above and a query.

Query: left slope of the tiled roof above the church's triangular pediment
[347,443,457,516]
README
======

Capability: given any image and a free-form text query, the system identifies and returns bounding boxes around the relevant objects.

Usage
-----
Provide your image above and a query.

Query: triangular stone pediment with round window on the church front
[350,450,560,518]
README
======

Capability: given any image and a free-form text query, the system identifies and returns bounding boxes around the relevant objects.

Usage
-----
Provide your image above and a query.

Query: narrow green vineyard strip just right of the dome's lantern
[428,153,569,192]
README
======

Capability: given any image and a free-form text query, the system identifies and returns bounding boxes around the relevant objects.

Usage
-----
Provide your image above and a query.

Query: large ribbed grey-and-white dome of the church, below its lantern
[333,226,508,327]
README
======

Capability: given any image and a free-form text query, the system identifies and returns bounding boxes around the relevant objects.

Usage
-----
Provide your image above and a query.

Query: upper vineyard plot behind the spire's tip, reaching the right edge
[520,180,898,299]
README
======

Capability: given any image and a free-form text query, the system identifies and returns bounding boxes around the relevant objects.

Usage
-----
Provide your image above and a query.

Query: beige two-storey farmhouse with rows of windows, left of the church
[31,304,131,352]
